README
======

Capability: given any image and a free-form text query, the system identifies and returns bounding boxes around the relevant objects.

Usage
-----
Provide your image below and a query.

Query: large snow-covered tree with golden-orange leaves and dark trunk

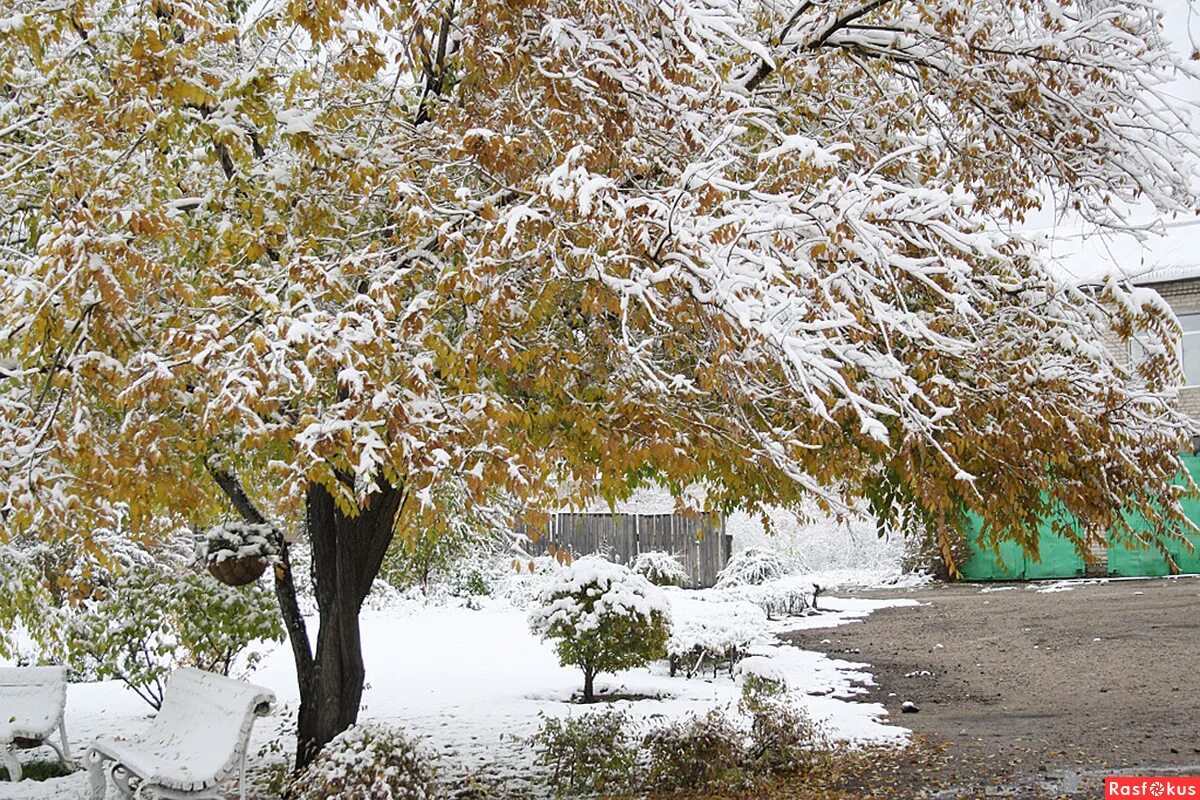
[0,0,1198,764]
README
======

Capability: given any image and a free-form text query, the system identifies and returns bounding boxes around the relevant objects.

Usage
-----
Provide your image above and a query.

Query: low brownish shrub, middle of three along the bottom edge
[643,710,745,792]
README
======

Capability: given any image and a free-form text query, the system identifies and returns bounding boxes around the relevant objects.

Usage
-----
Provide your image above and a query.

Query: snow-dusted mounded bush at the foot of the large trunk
[283,726,438,800]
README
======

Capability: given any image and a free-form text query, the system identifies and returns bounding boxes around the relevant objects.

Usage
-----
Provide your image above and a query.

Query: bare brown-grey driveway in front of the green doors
[792,578,1200,798]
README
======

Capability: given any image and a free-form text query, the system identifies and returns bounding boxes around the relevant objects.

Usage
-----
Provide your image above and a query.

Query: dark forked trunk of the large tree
[296,485,403,769]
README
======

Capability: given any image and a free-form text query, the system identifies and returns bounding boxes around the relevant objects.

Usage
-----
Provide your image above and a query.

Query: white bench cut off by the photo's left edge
[0,667,72,781]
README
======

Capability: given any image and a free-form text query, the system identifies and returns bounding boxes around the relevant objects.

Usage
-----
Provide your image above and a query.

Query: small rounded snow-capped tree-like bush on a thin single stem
[529,555,670,703]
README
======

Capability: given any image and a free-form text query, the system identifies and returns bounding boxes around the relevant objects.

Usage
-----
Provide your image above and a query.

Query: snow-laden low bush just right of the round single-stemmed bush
[667,593,767,678]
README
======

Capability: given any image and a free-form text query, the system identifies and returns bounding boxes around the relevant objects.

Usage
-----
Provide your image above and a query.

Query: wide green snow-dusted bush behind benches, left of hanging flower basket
[66,565,283,709]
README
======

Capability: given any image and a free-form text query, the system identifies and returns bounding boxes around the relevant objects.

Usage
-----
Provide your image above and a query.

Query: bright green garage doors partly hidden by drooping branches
[962,456,1200,581]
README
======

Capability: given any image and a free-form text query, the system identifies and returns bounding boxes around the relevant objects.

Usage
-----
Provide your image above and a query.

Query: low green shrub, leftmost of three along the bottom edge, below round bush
[530,711,638,796]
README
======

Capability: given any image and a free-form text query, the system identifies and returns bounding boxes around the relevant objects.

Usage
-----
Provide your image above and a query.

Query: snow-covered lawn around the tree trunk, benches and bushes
[0,590,914,800]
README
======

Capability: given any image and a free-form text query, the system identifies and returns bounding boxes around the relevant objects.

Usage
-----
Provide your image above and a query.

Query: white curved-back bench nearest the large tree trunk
[84,669,275,800]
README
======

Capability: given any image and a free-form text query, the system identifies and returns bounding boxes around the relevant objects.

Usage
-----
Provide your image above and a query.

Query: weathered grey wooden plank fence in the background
[523,512,733,589]
